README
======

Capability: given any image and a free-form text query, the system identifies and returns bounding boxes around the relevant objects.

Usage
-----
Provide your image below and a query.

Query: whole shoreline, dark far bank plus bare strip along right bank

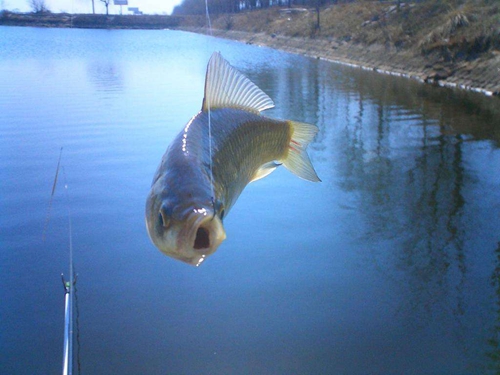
[0,12,500,97]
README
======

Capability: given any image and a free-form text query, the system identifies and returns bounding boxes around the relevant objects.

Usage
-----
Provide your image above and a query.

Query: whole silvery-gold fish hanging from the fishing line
[145,52,320,266]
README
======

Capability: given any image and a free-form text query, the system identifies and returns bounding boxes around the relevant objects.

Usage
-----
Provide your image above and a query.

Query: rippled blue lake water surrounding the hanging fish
[0,27,500,375]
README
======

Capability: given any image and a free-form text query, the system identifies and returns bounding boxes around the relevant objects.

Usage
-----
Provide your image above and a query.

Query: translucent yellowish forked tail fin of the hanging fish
[283,121,321,182]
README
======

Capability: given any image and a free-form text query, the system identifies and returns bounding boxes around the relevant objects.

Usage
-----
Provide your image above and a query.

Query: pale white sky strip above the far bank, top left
[0,0,182,14]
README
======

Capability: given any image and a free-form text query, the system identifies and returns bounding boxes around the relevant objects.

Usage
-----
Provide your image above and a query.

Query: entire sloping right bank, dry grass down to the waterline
[180,0,500,96]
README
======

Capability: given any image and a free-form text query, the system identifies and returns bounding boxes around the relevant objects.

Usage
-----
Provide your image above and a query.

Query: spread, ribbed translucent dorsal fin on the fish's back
[202,52,274,113]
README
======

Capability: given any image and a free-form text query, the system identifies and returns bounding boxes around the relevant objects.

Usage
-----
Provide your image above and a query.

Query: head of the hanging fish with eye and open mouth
[146,182,226,266]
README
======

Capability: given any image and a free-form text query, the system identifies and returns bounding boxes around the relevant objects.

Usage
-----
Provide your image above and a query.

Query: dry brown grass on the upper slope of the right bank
[209,0,500,59]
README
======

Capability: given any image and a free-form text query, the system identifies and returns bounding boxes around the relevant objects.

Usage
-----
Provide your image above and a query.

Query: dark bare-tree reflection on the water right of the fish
[252,57,500,371]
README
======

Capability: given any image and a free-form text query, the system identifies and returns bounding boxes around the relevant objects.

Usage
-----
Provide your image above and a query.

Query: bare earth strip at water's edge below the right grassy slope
[182,27,500,97]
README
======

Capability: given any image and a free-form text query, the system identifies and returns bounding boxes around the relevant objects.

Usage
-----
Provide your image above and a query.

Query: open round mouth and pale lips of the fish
[177,208,226,266]
